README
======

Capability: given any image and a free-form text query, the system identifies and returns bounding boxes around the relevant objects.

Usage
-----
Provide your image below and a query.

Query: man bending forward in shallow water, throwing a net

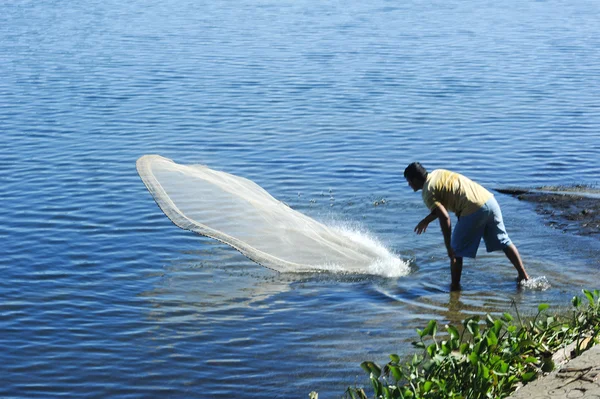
[404,162,529,290]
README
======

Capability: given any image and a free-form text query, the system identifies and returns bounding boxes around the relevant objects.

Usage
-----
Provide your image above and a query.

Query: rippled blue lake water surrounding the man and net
[0,0,600,398]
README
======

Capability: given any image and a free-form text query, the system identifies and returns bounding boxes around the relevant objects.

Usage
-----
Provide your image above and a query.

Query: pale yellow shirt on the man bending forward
[423,169,493,216]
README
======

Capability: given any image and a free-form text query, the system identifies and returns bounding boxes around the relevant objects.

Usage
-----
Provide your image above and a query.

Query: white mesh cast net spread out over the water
[136,155,408,276]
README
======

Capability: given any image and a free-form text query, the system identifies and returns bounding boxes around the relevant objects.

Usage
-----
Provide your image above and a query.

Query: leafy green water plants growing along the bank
[344,290,600,399]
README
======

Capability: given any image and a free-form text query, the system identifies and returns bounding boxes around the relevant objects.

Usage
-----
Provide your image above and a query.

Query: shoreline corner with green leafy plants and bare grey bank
[344,290,600,399]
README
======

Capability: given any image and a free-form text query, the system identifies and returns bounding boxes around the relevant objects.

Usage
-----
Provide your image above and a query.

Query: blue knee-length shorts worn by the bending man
[451,197,512,258]
